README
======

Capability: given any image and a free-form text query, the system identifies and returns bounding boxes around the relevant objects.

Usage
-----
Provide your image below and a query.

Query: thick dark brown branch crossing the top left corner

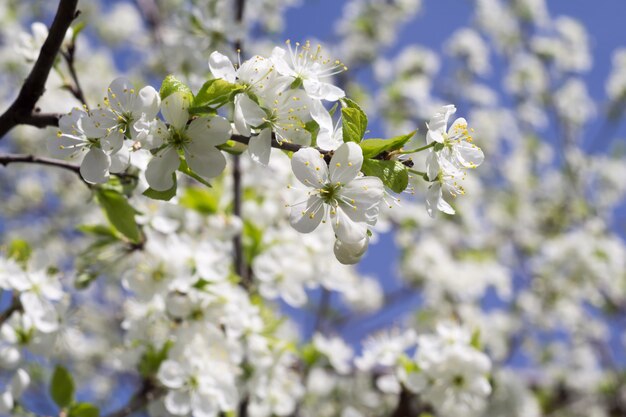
[0,0,78,139]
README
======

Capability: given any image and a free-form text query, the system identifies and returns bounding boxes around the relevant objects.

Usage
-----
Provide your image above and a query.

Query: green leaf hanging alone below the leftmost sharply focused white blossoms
[96,188,141,243]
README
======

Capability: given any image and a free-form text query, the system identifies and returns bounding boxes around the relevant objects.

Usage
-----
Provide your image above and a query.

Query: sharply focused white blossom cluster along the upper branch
[49,41,483,264]
